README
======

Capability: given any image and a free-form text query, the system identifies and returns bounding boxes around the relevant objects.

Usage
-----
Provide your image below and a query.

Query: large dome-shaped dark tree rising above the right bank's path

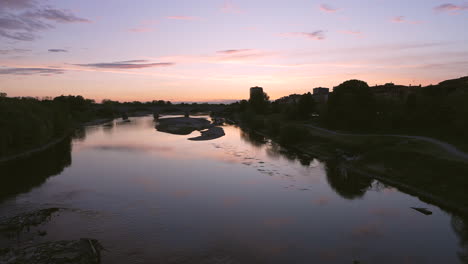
[326,80,376,129]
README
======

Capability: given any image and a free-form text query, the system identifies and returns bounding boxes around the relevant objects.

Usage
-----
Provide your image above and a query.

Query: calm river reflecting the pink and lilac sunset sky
[0,117,468,264]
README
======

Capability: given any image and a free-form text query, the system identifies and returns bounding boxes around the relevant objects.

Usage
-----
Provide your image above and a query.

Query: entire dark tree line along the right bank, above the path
[230,77,468,144]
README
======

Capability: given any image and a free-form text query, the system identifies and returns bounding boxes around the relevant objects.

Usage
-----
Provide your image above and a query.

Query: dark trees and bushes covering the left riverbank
[0,96,108,157]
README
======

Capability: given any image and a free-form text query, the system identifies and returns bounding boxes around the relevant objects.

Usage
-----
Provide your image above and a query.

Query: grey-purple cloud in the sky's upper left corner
[0,0,91,41]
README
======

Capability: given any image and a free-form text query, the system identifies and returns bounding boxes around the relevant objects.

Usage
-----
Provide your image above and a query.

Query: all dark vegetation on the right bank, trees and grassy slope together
[228,77,468,212]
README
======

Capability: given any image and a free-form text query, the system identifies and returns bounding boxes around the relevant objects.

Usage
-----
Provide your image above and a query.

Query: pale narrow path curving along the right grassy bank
[304,124,468,161]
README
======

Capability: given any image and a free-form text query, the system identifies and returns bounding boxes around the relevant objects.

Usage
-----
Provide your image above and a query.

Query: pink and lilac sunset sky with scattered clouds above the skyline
[0,0,468,101]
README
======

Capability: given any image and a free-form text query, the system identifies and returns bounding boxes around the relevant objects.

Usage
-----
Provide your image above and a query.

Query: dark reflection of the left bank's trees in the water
[0,137,72,202]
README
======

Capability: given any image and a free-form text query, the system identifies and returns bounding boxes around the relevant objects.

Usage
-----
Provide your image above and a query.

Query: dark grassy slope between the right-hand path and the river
[233,116,468,215]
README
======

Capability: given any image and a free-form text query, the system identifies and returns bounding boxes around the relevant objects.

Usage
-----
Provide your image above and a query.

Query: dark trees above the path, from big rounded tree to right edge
[320,77,468,150]
